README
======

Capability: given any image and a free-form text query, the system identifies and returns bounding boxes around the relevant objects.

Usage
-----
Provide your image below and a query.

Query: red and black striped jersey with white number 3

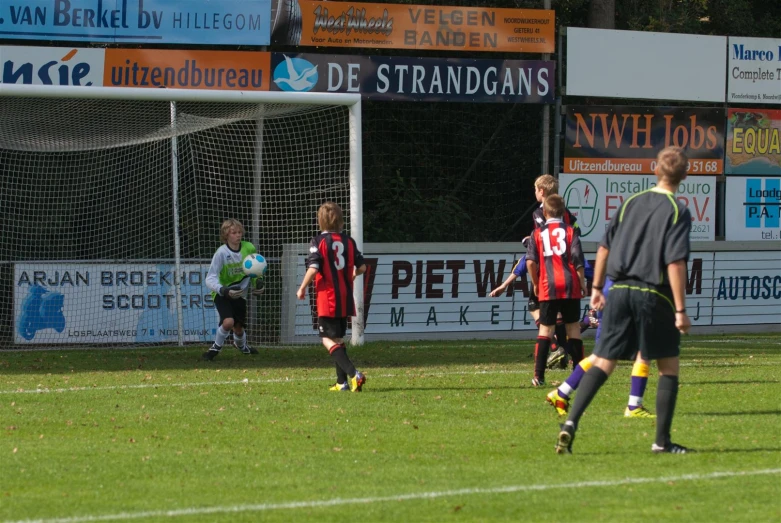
[306,232,364,318]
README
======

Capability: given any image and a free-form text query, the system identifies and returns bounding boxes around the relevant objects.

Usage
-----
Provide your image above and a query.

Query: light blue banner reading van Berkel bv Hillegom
[0,0,271,45]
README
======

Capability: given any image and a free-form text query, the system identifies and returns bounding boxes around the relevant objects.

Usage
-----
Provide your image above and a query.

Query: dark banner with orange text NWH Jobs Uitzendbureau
[564,106,725,176]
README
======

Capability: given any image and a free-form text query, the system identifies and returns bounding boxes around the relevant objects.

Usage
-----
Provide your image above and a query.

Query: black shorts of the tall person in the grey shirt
[594,282,681,360]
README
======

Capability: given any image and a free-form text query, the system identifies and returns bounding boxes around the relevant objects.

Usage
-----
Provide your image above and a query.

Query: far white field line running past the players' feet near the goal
[0,362,778,395]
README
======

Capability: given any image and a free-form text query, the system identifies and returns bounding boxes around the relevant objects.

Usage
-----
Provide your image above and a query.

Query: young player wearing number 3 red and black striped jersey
[296,202,366,392]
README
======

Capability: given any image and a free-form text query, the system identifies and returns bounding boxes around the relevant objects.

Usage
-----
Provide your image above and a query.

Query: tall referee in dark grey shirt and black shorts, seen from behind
[556,147,692,454]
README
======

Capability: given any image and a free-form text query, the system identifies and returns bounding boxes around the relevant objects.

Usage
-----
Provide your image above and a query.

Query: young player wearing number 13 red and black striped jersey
[526,194,586,387]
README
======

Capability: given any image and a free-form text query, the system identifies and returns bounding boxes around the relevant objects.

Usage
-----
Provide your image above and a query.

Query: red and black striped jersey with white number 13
[526,218,583,301]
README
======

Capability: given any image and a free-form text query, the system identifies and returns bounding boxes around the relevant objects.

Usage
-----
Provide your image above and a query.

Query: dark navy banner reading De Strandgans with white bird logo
[271,53,554,103]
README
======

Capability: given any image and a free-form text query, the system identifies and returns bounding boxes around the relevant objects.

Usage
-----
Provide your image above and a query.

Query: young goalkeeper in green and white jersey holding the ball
[203,219,263,361]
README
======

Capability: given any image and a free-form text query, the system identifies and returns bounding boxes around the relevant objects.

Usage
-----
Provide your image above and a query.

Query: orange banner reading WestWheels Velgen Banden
[271,0,556,53]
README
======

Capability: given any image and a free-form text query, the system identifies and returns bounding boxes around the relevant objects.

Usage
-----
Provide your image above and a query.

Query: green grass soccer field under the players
[0,335,781,523]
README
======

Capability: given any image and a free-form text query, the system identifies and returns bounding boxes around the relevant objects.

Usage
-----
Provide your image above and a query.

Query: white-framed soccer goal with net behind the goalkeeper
[0,85,363,348]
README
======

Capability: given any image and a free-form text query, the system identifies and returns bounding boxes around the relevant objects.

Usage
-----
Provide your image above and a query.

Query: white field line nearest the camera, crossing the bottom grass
[6,469,781,523]
